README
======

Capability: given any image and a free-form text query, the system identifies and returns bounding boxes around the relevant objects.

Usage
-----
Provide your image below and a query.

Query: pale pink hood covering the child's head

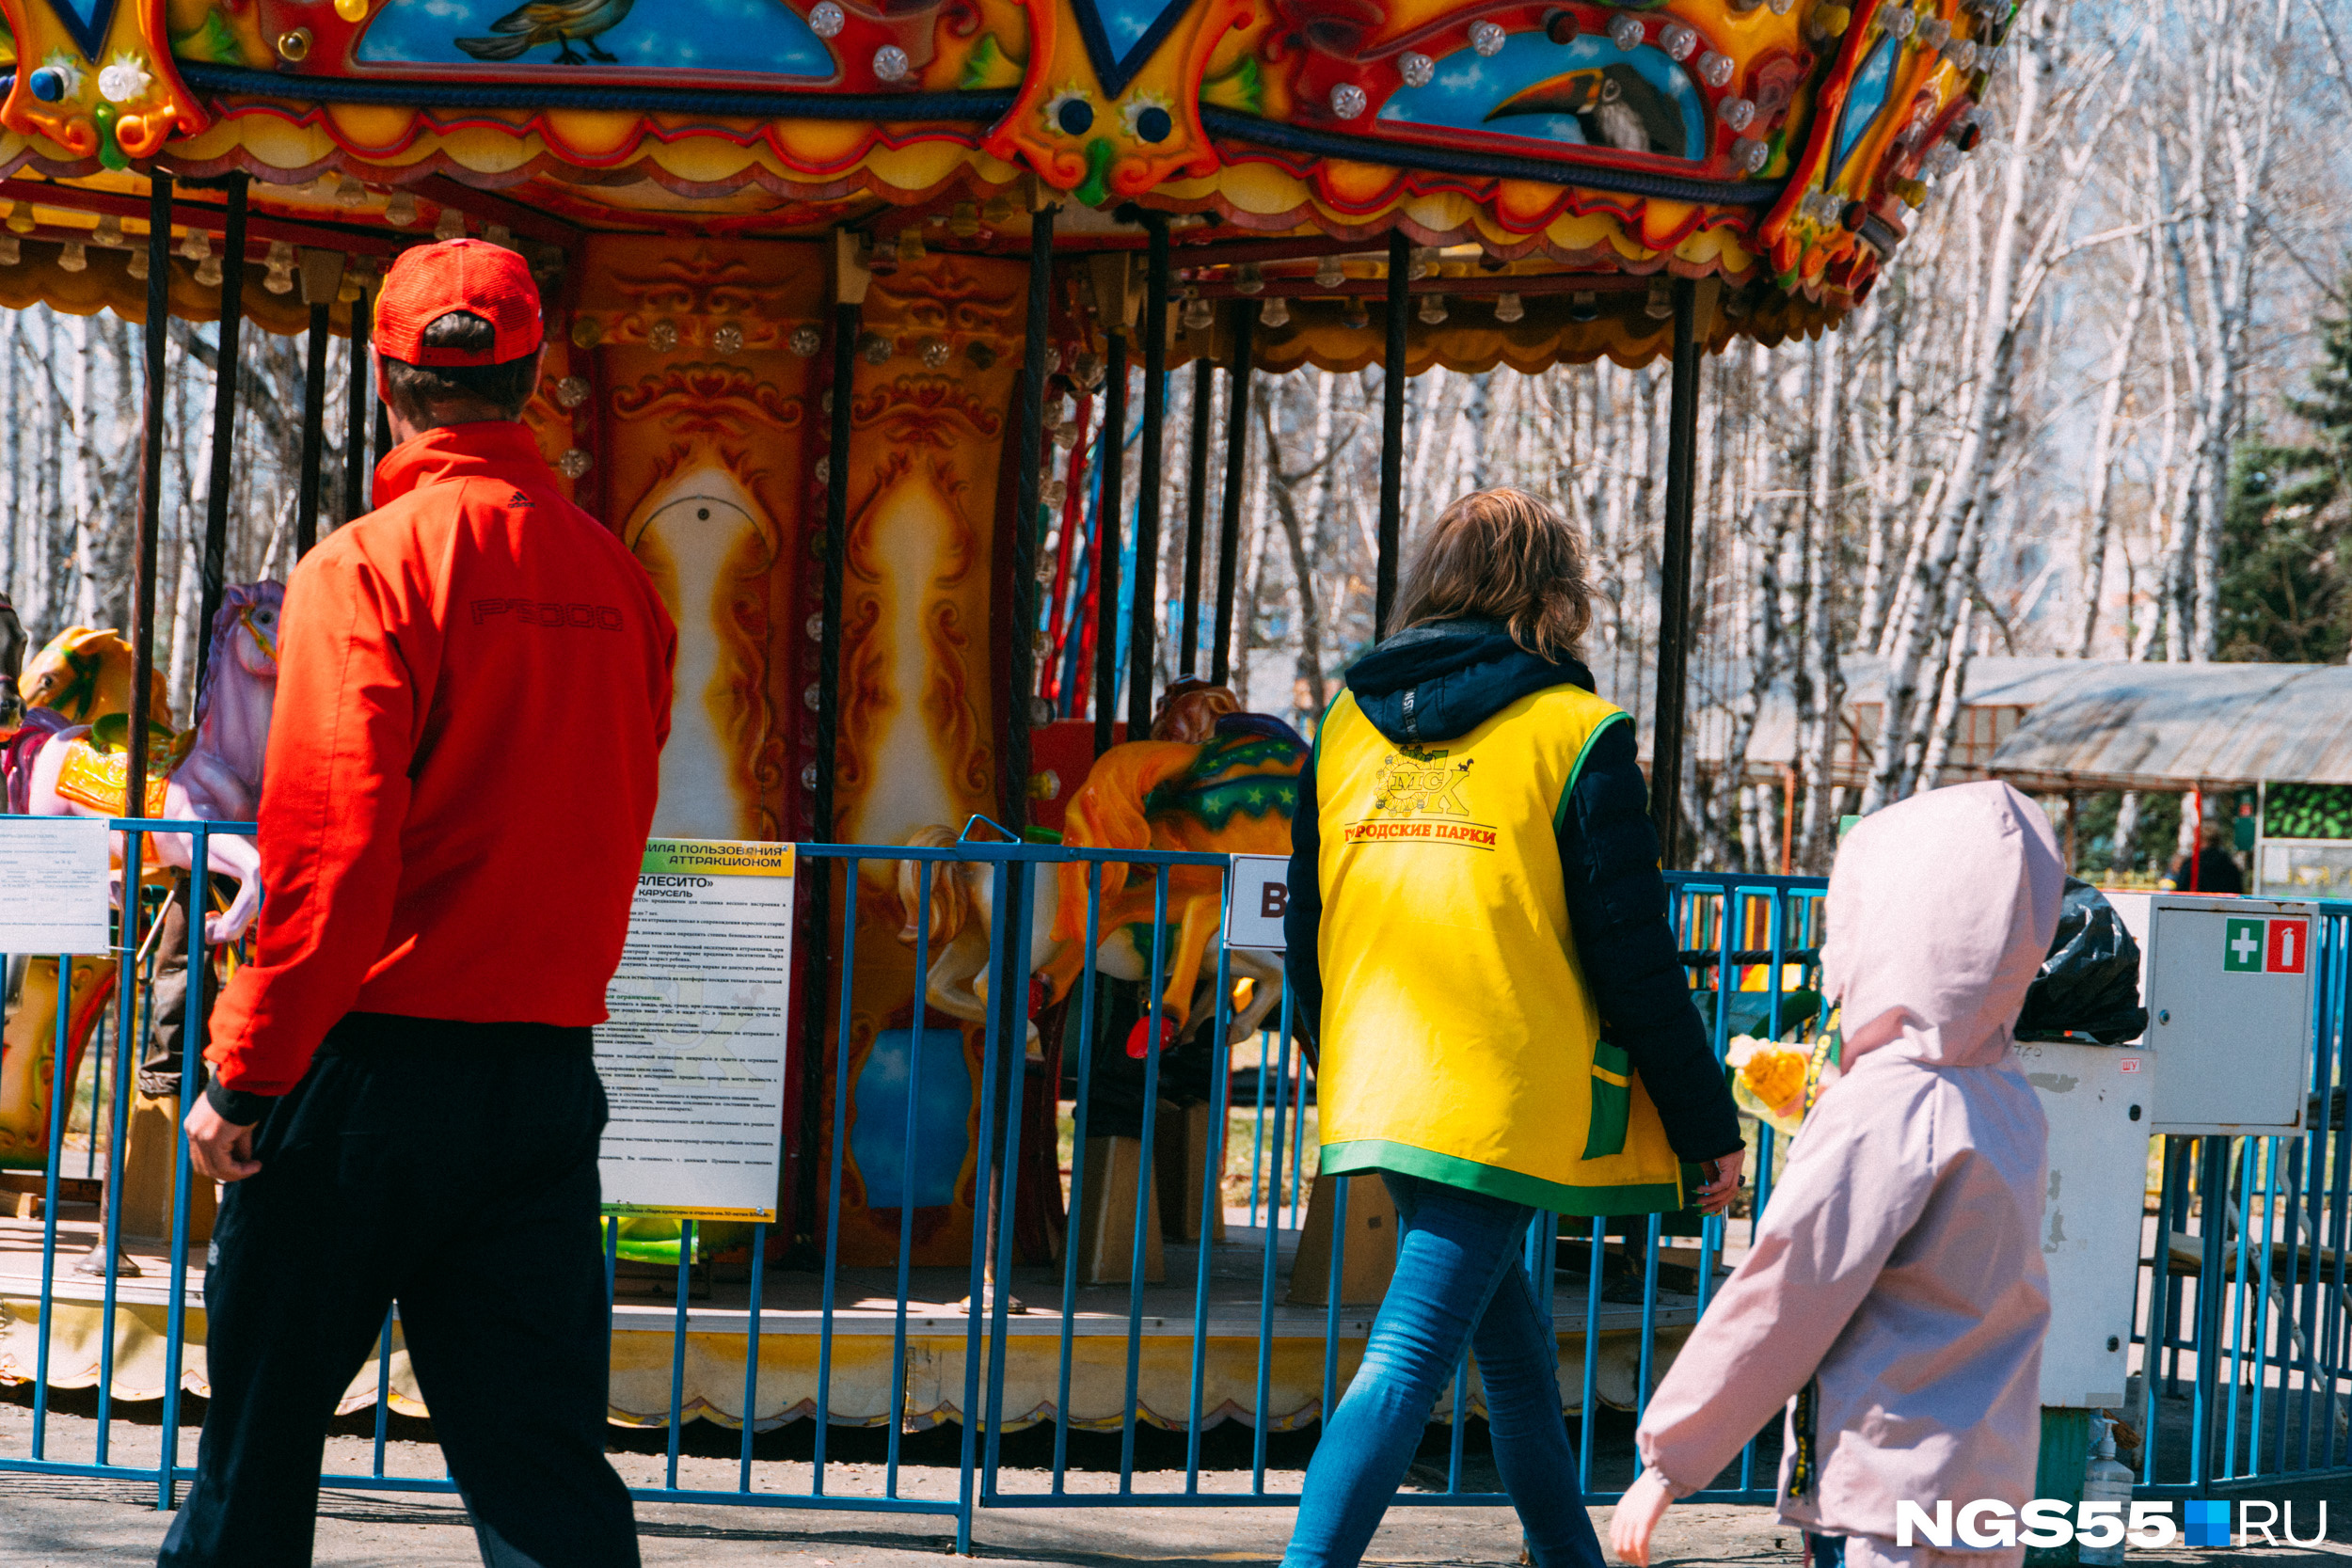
[1820,783,2065,1068]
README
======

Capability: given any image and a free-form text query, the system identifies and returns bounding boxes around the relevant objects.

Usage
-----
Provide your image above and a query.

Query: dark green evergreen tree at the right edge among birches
[2220,281,2352,665]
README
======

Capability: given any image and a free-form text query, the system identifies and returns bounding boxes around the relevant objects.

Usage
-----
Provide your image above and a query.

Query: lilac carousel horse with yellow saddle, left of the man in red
[19,583,285,945]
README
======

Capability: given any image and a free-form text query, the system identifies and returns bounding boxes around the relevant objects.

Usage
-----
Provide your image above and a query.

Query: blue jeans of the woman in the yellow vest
[1282,1171,1604,1568]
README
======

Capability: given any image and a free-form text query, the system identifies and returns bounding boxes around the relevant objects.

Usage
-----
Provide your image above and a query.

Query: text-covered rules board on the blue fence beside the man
[596,839,793,1220]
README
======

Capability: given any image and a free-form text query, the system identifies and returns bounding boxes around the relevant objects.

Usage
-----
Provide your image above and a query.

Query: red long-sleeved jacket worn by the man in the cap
[205,423,677,1096]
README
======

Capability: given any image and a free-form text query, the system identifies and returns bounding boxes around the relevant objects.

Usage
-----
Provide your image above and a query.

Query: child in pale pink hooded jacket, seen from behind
[1612,783,2065,1568]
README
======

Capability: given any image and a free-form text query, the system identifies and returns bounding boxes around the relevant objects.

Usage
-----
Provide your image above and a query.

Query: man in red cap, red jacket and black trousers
[160,240,677,1568]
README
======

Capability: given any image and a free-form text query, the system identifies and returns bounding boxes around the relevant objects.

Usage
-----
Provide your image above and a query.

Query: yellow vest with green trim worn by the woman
[1315,687,1682,1215]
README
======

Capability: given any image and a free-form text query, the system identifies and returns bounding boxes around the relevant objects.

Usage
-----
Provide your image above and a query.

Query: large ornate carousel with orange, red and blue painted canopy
[0,0,2011,1427]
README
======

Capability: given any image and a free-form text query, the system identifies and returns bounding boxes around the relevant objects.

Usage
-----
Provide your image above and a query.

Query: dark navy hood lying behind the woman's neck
[1348,621,1593,745]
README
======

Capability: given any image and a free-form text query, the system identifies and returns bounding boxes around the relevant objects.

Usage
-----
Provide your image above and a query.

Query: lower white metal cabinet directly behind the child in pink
[2018,1041,2157,1411]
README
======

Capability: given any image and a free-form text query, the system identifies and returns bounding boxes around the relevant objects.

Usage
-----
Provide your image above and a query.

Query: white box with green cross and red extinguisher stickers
[2143,894,2319,1133]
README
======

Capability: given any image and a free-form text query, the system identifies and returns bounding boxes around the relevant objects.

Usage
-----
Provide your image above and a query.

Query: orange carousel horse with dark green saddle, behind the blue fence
[898,682,1308,1055]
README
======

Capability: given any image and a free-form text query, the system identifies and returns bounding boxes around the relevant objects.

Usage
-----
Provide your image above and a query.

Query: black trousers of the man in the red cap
[158,1013,638,1568]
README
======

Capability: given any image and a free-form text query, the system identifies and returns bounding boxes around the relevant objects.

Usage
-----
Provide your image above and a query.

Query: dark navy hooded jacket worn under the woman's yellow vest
[1284,621,1740,1162]
